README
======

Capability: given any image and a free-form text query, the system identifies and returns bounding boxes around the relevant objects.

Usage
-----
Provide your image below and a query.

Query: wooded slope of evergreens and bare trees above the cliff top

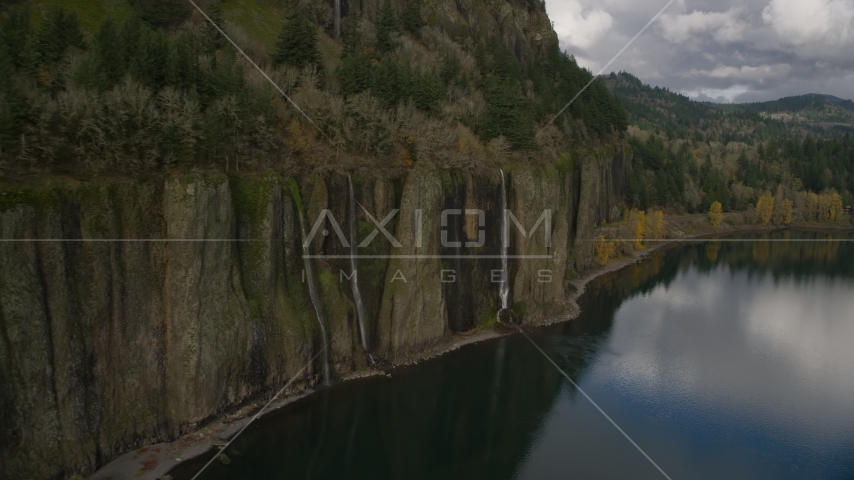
[0,0,627,176]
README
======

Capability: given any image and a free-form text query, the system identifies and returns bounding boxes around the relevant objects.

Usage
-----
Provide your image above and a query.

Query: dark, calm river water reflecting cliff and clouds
[172,232,854,480]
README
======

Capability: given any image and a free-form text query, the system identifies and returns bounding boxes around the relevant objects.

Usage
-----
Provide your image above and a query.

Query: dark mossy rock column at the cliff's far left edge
[0,207,63,478]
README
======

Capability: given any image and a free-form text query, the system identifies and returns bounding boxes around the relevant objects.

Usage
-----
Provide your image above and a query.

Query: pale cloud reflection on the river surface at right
[600,268,854,442]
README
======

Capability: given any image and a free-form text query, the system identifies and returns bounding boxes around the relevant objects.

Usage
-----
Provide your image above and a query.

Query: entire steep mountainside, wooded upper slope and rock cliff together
[0,0,630,478]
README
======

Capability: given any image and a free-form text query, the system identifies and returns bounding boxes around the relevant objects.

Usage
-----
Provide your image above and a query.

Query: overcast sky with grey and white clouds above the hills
[546,0,854,102]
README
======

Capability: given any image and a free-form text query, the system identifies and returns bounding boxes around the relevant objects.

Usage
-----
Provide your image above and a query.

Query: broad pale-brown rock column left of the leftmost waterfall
[164,176,250,433]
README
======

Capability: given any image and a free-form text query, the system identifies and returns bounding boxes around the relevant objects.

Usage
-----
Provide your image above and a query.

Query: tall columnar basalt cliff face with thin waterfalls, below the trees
[0,154,628,478]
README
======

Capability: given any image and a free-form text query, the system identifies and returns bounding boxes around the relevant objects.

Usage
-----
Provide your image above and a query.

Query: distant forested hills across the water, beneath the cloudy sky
[605,73,854,220]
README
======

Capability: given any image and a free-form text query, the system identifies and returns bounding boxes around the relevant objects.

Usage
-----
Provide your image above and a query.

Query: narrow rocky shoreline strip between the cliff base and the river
[89,214,854,480]
